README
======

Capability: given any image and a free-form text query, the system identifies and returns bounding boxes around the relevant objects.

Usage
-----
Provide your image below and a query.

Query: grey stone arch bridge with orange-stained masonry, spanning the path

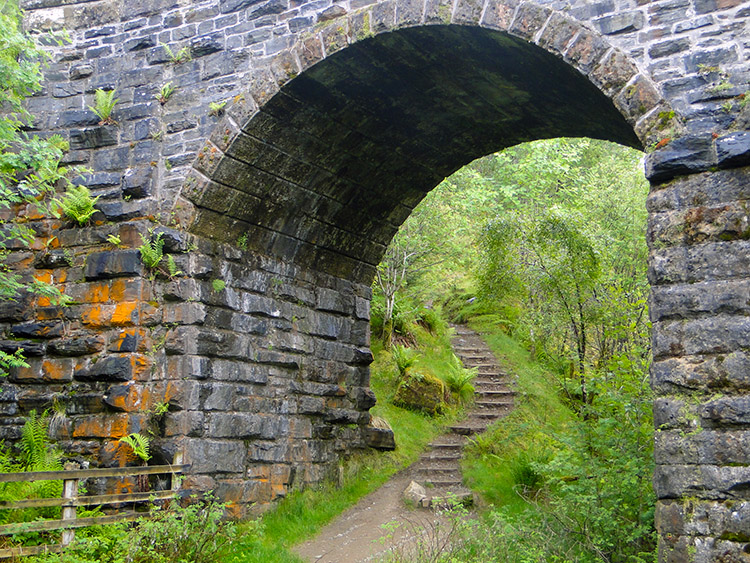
[0,0,750,562]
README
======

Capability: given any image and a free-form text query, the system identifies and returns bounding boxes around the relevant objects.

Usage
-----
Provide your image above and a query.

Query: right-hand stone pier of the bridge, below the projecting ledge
[648,162,750,562]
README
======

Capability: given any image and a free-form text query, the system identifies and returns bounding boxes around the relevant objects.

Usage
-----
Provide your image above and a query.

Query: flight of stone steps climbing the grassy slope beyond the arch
[417,326,513,506]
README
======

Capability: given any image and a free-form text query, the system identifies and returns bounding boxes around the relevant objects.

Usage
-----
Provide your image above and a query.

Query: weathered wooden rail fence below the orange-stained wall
[0,454,190,559]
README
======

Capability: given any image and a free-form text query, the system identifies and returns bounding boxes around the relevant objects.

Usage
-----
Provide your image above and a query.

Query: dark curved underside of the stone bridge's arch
[190,25,641,283]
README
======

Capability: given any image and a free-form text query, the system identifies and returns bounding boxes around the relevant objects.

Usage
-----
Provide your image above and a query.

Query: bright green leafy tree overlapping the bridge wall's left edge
[0,0,71,376]
